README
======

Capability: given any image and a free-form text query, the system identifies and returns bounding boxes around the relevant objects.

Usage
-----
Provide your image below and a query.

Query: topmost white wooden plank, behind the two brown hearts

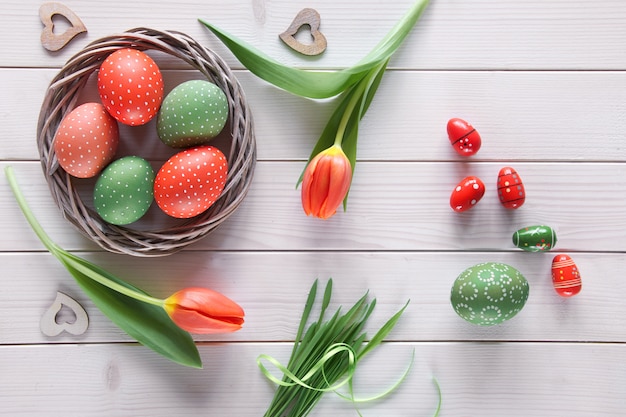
[0,0,626,70]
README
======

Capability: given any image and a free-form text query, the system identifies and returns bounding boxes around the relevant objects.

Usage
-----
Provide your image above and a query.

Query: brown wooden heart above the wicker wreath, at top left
[39,2,87,52]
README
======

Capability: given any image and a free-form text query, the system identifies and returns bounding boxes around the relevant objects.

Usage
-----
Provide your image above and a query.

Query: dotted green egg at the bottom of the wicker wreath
[93,156,155,226]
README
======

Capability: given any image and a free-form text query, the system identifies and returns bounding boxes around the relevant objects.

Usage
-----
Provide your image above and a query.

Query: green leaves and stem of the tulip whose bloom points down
[199,0,429,218]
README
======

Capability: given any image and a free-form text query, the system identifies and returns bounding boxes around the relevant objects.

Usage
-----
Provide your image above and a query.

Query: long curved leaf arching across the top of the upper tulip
[199,0,428,98]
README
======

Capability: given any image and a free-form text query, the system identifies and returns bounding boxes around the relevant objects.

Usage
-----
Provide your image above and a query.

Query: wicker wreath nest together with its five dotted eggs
[37,28,256,256]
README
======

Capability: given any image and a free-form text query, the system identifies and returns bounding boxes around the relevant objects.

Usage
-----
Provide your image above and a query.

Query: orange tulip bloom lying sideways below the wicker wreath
[163,287,244,334]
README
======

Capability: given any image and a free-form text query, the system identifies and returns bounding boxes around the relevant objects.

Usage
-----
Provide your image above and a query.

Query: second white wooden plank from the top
[0,69,626,162]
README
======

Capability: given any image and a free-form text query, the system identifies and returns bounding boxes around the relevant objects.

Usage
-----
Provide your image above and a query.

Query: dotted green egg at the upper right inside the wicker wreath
[157,80,228,148]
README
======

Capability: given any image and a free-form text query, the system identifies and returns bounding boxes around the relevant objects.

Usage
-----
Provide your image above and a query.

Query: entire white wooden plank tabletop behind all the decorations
[0,0,626,417]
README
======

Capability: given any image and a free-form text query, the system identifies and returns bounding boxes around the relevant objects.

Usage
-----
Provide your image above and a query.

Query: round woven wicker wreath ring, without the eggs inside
[37,28,256,256]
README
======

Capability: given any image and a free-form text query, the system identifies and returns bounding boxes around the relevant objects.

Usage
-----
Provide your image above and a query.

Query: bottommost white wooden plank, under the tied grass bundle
[0,342,626,417]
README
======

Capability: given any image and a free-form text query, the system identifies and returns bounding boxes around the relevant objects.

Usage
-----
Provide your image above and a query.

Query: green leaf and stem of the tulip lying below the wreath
[5,167,202,368]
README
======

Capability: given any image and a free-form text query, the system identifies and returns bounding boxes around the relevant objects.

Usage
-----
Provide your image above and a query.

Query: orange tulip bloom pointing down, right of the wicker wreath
[302,145,352,219]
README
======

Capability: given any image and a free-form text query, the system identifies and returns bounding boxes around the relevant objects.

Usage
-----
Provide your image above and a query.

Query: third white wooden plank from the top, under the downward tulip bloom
[0,161,626,252]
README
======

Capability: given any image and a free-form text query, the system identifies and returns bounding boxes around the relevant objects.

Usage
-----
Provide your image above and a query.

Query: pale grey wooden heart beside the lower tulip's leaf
[39,292,89,337]
